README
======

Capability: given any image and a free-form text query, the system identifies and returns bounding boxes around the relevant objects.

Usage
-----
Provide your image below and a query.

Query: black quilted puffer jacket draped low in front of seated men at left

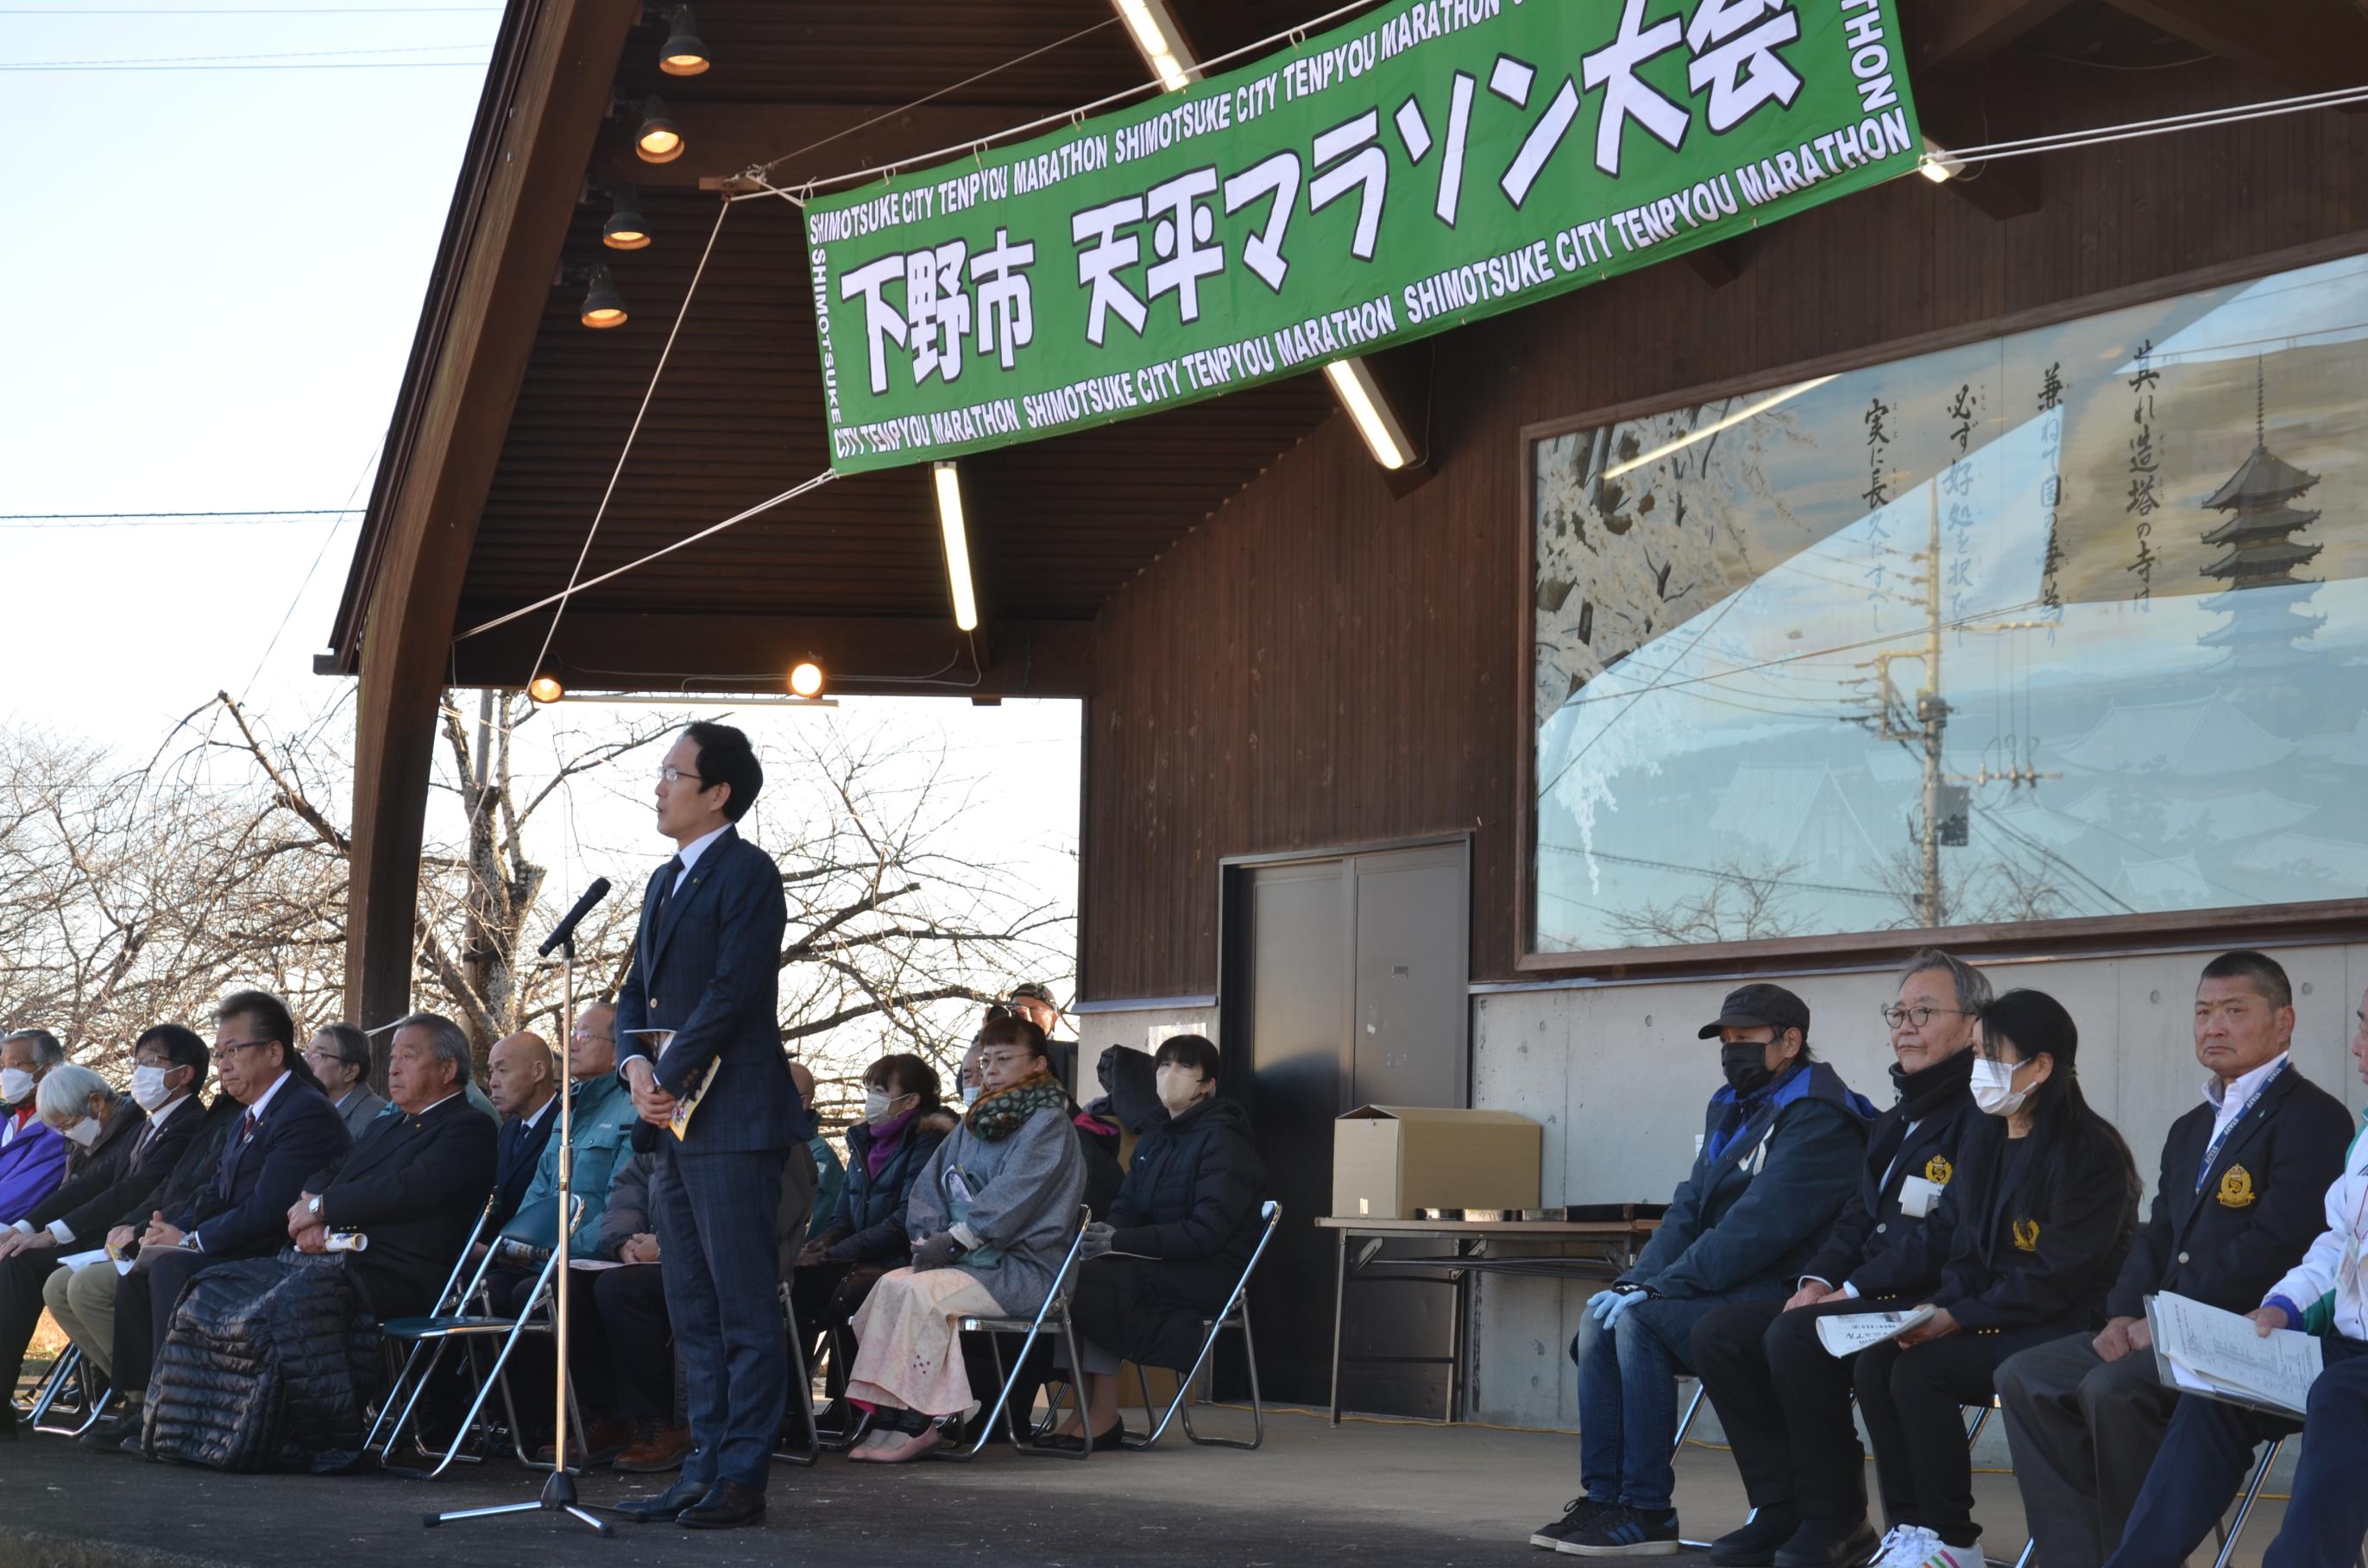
[147,1253,376,1470]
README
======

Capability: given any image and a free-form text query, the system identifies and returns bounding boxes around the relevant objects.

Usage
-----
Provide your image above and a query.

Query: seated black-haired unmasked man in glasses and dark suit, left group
[83,990,353,1452]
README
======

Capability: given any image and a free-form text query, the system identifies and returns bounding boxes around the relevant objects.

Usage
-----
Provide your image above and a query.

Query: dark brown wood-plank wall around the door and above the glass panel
[1082,61,2368,999]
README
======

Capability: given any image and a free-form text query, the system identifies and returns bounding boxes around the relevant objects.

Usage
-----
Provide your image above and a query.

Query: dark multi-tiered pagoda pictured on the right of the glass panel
[2197,362,2326,675]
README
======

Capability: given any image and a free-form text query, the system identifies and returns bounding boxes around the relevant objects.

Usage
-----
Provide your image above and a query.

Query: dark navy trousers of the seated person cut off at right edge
[2105,1333,2368,1568]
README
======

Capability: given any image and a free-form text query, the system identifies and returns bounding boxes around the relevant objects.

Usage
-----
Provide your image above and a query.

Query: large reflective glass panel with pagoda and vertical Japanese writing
[1532,258,2368,952]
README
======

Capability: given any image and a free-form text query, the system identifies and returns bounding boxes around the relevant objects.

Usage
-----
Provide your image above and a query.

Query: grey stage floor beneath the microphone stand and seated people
[0,1409,2283,1568]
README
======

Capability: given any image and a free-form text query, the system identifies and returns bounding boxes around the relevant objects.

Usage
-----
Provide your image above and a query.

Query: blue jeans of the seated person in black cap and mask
[1570,1300,1719,1514]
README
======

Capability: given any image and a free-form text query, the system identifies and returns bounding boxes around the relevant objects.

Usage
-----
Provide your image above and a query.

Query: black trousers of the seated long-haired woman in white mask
[1856,1324,2079,1546]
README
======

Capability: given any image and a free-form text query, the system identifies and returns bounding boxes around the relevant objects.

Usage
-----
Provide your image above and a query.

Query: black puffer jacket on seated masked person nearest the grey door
[1111,1099,1267,1307]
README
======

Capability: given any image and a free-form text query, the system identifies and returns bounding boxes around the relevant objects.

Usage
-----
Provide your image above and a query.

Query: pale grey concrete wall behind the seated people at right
[1471,942,2368,1431]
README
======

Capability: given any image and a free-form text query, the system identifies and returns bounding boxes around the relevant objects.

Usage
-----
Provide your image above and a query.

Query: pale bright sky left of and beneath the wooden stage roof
[0,12,1078,990]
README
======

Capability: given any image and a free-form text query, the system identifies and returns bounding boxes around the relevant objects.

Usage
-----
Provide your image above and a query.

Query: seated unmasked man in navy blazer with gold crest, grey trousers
[1999,952,2352,1568]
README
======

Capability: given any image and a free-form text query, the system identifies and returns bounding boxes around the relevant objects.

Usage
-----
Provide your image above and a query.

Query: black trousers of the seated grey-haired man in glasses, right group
[1691,1298,1913,1523]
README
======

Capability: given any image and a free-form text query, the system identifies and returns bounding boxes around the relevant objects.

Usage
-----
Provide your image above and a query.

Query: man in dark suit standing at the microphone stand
[615,725,812,1527]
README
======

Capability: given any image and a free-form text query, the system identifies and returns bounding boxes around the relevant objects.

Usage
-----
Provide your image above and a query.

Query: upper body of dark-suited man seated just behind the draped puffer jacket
[289,1014,494,1322]
